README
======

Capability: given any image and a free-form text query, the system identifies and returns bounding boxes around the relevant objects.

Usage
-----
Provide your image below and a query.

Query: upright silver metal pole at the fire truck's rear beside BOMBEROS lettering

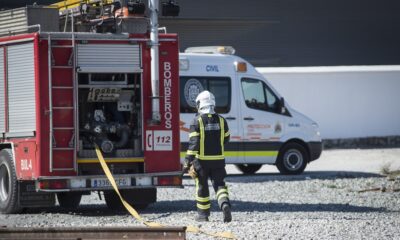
[149,0,161,124]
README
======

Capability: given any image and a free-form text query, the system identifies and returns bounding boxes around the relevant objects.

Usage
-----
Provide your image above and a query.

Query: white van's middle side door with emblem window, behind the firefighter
[180,76,243,163]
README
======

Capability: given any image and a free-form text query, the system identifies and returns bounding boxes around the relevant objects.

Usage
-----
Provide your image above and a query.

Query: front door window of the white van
[242,78,279,113]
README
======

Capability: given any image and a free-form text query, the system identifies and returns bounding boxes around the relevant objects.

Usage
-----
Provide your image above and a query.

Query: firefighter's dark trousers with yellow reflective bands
[195,163,230,216]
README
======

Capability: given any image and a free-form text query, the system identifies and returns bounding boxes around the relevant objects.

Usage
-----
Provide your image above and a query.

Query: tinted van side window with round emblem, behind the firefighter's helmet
[180,76,231,113]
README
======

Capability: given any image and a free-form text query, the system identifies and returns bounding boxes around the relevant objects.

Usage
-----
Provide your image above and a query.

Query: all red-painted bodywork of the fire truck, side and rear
[0,33,180,180]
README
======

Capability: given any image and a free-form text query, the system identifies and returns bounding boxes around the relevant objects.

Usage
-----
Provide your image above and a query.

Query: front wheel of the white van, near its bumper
[276,142,309,175]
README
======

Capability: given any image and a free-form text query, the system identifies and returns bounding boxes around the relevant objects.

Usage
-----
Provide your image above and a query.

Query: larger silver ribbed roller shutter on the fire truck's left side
[7,43,36,133]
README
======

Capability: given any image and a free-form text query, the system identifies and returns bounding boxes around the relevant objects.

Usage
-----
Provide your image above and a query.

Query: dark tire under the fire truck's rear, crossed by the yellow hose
[104,188,157,211]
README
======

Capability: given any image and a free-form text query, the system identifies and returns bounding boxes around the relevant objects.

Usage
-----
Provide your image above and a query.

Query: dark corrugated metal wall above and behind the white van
[160,0,400,66]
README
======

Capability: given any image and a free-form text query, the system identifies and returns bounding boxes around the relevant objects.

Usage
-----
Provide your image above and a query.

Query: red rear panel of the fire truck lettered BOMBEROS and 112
[143,35,180,172]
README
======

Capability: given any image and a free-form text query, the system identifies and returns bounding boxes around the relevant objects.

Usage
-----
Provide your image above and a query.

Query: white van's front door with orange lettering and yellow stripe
[239,76,285,163]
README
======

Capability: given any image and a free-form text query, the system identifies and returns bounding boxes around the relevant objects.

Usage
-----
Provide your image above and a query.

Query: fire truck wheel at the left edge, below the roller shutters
[0,149,22,214]
